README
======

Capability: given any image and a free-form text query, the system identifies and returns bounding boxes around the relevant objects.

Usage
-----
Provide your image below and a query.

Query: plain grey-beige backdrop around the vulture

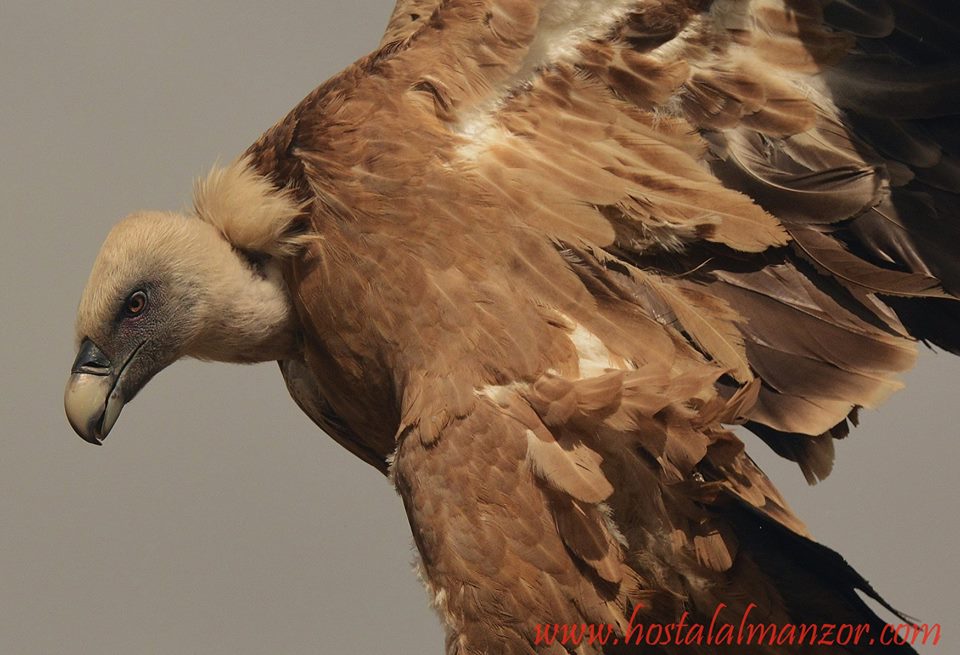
[0,0,960,655]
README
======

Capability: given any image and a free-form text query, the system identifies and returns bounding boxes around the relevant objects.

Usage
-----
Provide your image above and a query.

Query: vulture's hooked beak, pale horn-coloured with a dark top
[63,339,142,446]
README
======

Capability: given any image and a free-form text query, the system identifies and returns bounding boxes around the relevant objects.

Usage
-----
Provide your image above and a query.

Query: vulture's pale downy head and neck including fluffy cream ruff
[64,161,299,444]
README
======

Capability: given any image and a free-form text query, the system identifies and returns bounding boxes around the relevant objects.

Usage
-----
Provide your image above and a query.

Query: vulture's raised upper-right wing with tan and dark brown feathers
[366,0,960,480]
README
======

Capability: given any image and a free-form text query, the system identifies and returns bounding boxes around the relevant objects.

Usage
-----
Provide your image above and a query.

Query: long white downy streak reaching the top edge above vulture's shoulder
[453,0,637,159]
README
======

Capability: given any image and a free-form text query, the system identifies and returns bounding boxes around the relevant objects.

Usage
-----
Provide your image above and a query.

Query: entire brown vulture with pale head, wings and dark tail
[66,0,960,655]
